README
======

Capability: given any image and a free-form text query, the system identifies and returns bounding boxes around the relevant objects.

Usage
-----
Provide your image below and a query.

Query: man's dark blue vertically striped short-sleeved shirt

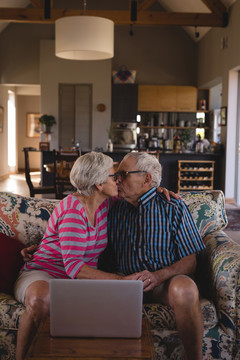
[108,188,205,275]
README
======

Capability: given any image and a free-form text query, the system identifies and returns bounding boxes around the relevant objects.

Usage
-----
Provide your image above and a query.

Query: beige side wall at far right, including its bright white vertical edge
[198,0,240,199]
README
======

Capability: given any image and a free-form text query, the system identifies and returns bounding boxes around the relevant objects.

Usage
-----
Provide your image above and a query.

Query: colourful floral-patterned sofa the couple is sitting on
[0,190,240,360]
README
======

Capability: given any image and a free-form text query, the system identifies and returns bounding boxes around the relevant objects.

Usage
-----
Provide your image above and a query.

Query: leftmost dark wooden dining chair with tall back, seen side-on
[23,147,55,197]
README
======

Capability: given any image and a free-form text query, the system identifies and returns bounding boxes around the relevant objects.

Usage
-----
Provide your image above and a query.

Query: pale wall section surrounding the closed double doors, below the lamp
[40,40,112,149]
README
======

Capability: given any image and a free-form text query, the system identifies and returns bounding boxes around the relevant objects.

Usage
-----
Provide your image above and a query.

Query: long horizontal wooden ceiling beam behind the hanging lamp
[0,8,225,27]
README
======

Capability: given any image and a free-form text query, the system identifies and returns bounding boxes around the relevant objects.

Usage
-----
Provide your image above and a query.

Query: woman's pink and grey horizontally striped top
[23,195,112,278]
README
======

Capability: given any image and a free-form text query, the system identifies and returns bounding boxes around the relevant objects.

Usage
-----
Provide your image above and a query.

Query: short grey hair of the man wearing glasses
[124,152,162,187]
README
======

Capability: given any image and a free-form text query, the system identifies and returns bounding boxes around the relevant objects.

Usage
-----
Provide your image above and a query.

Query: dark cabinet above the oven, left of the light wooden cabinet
[112,84,138,122]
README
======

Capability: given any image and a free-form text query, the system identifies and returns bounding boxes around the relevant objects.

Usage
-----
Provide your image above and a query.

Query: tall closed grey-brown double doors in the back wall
[59,84,92,151]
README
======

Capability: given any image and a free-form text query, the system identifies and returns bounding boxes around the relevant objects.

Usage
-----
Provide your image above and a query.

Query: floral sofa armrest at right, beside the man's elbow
[197,231,240,339]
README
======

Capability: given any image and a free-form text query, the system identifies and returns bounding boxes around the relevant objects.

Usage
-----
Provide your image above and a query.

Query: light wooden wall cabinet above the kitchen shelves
[138,85,197,112]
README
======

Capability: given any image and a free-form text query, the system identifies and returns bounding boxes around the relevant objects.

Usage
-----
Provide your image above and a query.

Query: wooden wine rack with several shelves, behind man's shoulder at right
[178,160,215,191]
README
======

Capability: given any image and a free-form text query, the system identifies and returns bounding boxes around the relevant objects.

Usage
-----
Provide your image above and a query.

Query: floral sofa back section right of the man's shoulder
[181,190,227,237]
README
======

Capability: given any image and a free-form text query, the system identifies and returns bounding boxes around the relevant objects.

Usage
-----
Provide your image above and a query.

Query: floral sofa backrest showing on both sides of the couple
[0,190,227,245]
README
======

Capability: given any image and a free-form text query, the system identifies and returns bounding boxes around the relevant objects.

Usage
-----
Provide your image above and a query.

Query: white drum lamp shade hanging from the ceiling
[55,15,114,60]
